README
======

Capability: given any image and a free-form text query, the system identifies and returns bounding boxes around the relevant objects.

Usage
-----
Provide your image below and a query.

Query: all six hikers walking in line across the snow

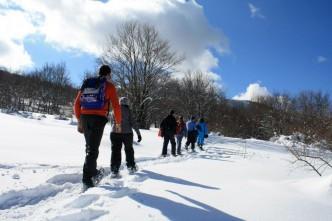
[74,65,208,190]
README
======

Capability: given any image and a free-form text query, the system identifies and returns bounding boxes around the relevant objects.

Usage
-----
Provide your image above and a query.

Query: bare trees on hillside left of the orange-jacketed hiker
[0,63,75,114]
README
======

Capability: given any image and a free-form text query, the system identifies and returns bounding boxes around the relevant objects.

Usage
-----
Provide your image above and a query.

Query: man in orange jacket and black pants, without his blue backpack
[74,65,121,188]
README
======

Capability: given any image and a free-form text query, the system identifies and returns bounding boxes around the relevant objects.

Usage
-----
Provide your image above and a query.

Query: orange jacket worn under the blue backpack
[74,81,121,124]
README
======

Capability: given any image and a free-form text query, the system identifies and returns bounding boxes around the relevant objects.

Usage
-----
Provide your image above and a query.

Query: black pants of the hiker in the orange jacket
[81,115,107,183]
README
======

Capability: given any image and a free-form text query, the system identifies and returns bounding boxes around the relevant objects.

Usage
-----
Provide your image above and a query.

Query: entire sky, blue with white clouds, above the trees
[0,0,332,99]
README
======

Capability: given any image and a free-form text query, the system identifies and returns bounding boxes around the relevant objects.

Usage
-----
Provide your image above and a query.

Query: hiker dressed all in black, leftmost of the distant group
[160,110,176,157]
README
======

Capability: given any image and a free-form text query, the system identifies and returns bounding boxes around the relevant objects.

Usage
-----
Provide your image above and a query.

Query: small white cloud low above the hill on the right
[233,83,271,101]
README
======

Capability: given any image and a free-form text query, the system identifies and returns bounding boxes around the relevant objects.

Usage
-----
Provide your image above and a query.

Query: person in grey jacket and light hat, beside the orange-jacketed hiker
[110,97,142,177]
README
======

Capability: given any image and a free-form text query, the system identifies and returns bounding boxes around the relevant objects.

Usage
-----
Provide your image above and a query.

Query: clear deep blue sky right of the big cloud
[198,0,332,96]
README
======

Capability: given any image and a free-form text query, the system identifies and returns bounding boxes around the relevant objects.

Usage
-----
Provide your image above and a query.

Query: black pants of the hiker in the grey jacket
[111,133,135,171]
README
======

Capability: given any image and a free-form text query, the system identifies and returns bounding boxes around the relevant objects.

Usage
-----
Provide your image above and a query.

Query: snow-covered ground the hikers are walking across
[0,113,332,221]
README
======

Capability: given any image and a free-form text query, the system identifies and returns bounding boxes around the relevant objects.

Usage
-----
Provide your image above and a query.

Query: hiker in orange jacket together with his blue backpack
[74,65,121,189]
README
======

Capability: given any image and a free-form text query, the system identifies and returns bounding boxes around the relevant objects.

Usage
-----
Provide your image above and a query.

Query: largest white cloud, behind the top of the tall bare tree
[0,0,230,77]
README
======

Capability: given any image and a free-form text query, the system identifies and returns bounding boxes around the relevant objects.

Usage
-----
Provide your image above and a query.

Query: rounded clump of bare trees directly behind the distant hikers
[154,71,224,130]
